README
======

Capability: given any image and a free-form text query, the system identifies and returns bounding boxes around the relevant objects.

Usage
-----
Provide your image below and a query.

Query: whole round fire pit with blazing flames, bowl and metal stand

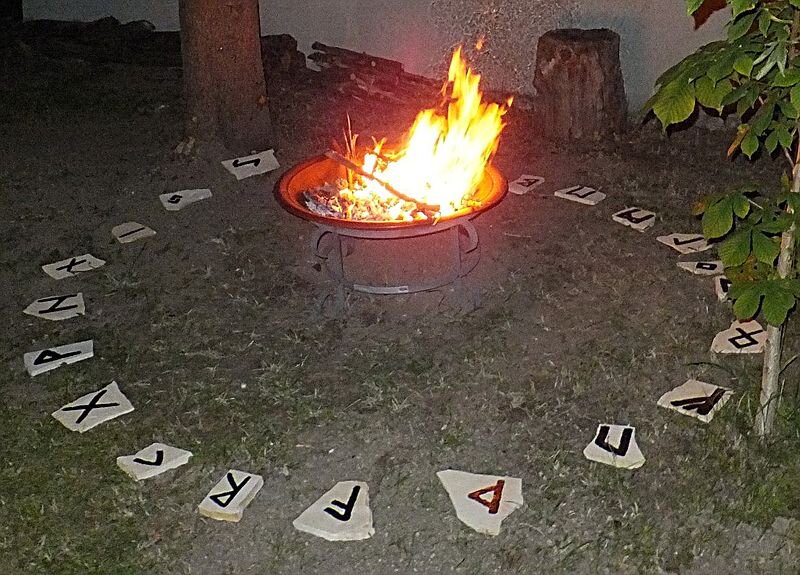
[275,51,510,307]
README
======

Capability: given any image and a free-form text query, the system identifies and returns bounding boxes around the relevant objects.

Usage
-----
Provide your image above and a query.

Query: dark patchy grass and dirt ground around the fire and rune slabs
[0,38,800,575]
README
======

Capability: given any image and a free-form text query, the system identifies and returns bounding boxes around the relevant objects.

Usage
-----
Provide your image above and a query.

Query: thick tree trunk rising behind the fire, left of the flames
[180,0,272,154]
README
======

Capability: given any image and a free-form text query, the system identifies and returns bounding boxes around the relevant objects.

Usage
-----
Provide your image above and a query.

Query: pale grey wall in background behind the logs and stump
[24,0,726,106]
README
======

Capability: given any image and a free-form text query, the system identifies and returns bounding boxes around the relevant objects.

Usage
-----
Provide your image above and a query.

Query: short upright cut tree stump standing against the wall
[534,28,627,141]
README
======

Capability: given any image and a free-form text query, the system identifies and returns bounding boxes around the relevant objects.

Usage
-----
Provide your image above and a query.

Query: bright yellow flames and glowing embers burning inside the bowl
[305,48,511,221]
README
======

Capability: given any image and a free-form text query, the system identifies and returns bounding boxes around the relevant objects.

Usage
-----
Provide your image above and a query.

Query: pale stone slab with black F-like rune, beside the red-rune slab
[292,481,375,541]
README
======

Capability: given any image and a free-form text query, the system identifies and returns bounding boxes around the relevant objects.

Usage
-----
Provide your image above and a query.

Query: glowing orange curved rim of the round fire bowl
[273,154,508,232]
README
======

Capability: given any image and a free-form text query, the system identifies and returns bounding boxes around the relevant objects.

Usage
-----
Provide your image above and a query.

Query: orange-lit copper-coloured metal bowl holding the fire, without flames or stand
[275,156,508,231]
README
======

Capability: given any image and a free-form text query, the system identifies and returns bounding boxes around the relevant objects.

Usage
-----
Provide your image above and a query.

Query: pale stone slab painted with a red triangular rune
[436,469,523,535]
